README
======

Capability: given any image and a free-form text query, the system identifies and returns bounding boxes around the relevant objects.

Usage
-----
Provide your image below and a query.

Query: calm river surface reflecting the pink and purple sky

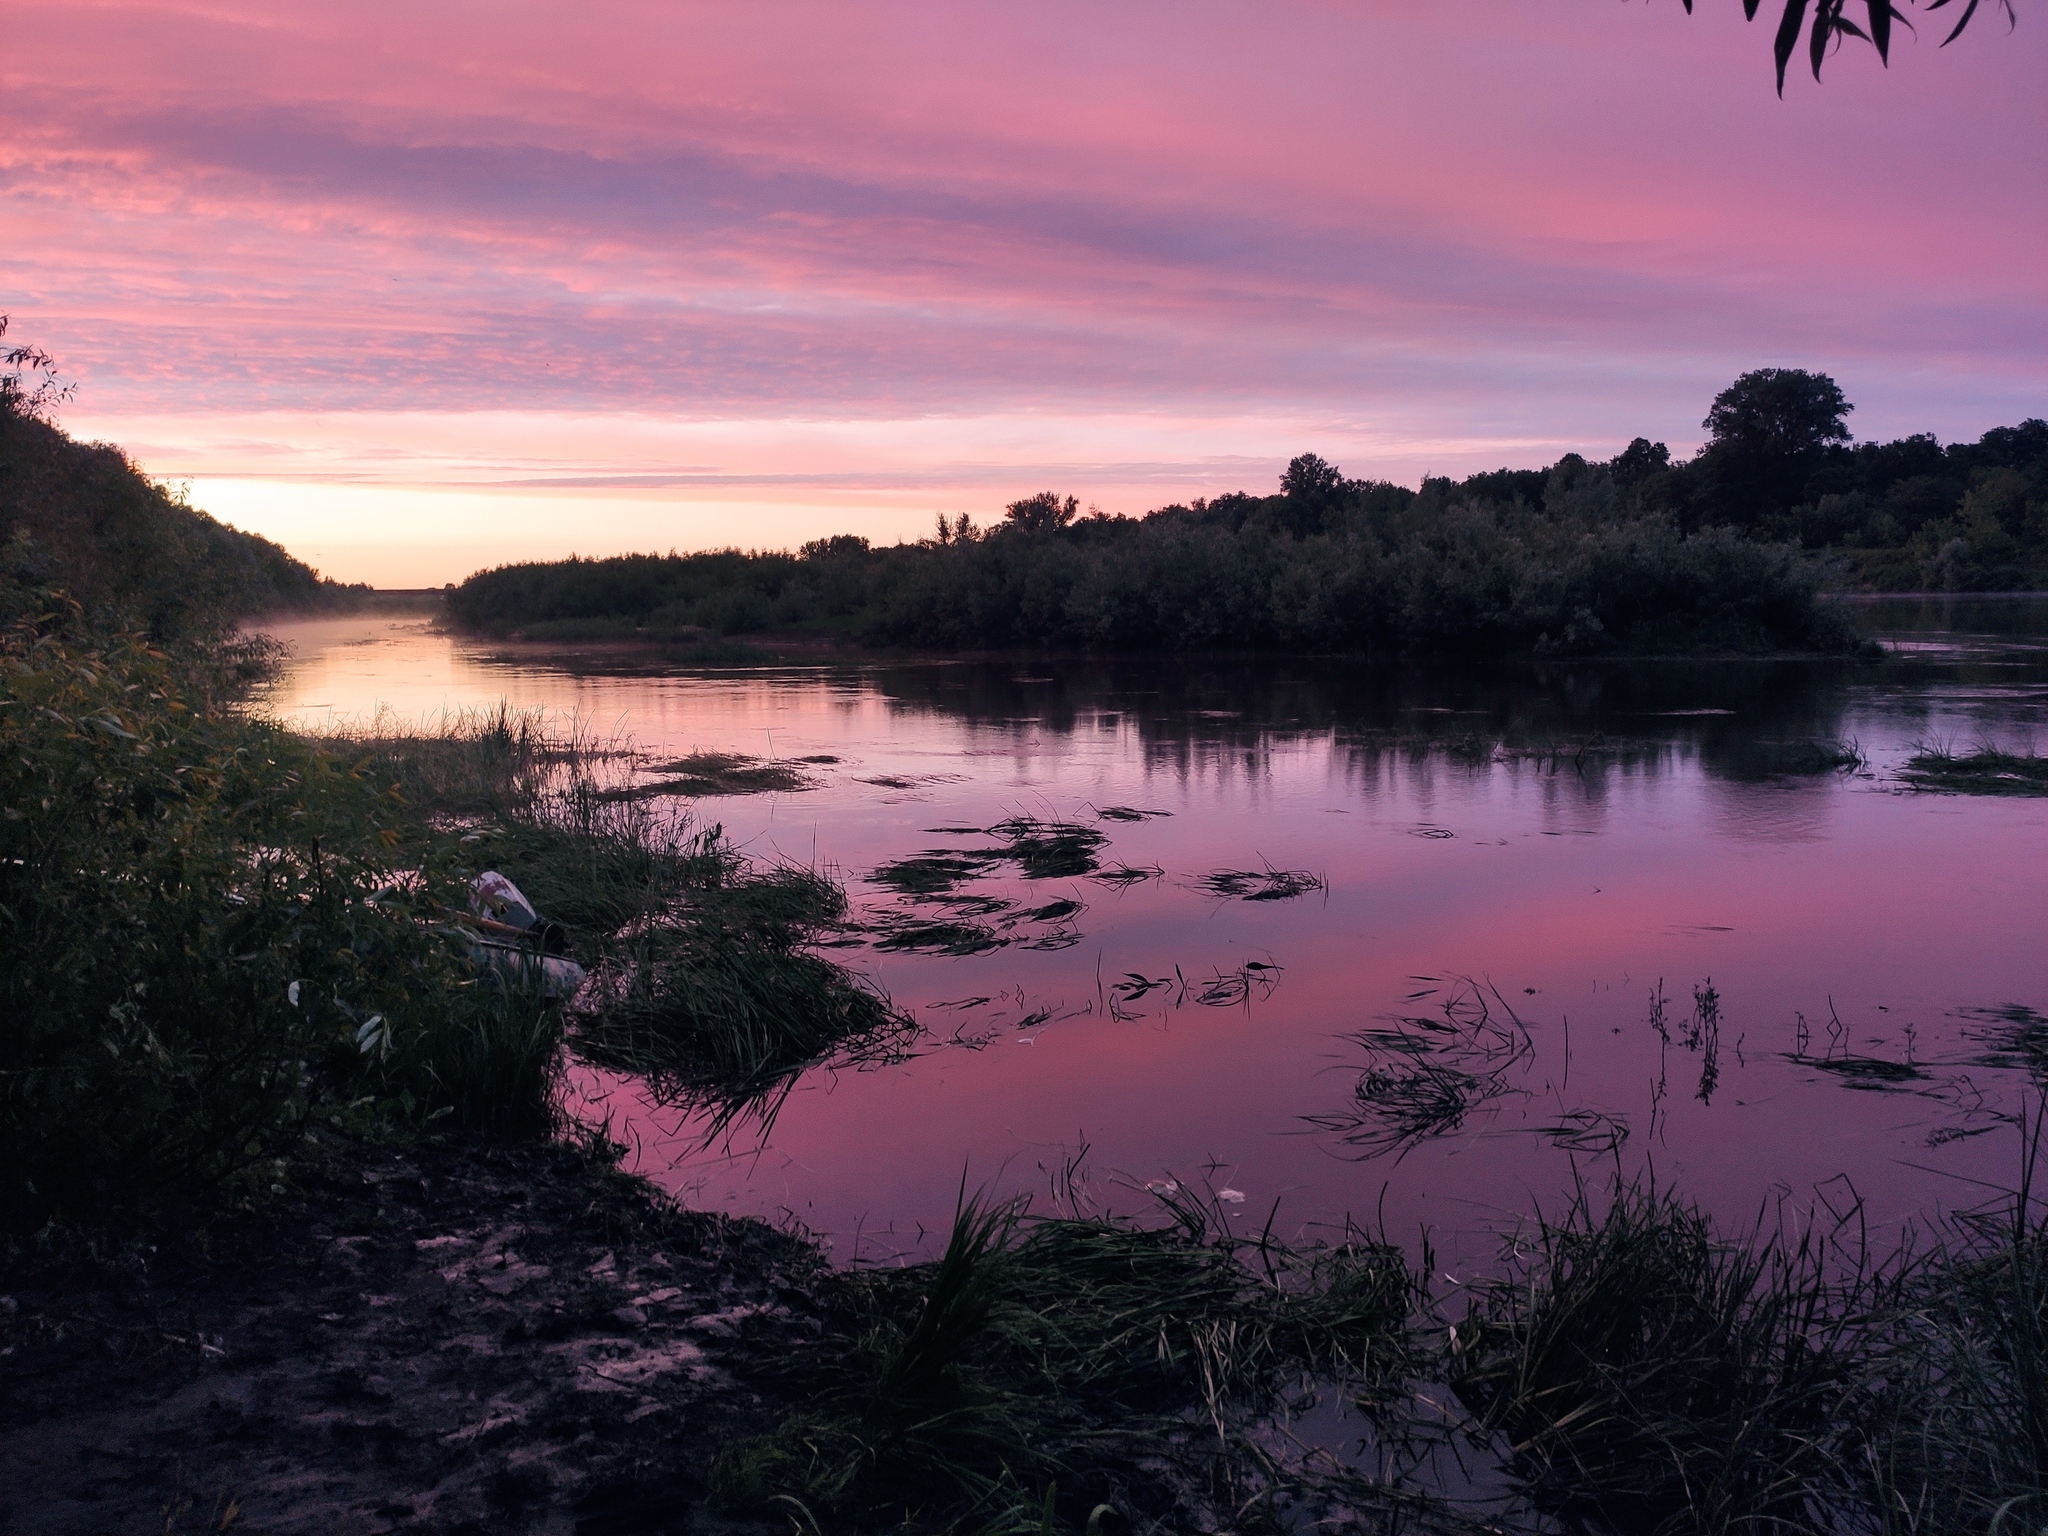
[268,598,2048,1274]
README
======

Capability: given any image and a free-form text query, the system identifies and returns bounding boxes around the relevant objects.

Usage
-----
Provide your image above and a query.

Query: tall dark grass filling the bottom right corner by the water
[1450,1120,2048,1536]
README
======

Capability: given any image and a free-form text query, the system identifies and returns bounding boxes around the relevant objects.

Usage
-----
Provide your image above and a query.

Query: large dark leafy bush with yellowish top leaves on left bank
[0,590,559,1231]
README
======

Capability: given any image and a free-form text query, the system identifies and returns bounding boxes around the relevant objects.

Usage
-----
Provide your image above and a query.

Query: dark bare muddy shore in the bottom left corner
[0,1137,819,1536]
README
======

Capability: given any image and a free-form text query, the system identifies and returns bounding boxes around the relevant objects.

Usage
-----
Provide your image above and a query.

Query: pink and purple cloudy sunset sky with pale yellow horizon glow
[0,0,2048,586]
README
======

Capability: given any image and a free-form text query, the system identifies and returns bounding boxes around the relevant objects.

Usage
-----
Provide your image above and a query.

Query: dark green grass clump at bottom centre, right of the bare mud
[715,1194,1413,1530]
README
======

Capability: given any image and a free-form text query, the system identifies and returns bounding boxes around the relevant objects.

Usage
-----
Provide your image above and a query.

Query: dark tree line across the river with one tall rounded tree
[449,369,2048,655]
